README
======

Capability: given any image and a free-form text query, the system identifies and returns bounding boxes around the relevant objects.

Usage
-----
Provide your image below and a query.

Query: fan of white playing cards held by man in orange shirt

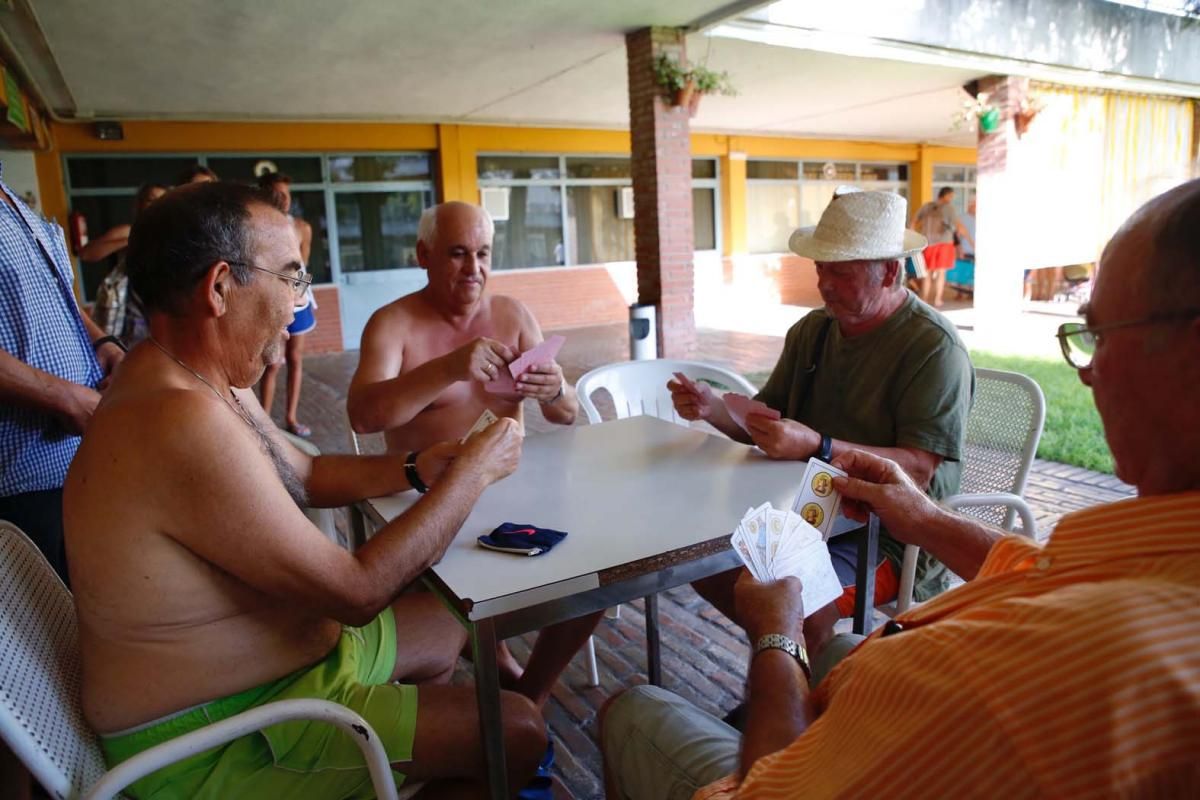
[730,503,842,616]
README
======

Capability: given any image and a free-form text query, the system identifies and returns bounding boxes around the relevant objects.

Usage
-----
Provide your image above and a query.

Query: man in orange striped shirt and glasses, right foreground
[602,181,1200,800]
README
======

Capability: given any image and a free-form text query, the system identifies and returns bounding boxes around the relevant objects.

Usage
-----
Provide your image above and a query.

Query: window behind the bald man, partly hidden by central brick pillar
[476,155,719,270]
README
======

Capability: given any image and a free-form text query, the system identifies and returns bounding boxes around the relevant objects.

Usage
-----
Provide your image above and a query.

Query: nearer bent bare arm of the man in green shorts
[158,391,521,625]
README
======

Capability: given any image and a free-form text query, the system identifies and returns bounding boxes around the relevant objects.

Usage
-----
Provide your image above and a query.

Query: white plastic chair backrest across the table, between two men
[575,359,757,426]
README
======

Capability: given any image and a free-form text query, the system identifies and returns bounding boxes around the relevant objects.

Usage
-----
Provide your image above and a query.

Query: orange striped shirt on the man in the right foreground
[695,492,1200,800]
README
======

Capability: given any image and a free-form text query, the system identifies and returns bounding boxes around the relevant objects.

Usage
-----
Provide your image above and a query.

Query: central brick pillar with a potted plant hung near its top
[625,28,696,359]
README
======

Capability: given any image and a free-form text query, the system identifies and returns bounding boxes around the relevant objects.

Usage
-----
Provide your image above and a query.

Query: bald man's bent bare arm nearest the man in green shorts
[346,306,514,433]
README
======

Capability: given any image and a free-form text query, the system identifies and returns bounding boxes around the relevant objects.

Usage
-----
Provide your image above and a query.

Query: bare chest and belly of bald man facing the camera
[355,293,541,452]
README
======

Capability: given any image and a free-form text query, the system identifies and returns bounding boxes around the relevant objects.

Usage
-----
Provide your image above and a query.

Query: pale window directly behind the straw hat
[746,160,908,253]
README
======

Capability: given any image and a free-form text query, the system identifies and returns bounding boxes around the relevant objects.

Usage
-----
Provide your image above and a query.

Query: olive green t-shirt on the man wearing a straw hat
[756,293,974,600]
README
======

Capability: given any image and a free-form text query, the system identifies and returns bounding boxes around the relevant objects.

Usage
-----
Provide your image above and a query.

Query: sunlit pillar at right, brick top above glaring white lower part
[974,76,1037,349]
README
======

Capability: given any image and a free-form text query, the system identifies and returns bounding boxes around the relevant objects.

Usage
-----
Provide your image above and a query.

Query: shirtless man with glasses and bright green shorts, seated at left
[64,184,546,799]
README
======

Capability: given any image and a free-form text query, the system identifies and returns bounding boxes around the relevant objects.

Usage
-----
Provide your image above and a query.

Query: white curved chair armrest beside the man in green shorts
[83,699,396,800]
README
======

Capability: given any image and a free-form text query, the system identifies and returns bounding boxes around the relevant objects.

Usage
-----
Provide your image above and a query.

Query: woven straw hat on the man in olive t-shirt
[787,187,925,261]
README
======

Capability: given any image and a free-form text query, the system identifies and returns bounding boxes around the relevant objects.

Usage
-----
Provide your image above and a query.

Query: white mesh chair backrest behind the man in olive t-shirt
[959,369,1046,529]
